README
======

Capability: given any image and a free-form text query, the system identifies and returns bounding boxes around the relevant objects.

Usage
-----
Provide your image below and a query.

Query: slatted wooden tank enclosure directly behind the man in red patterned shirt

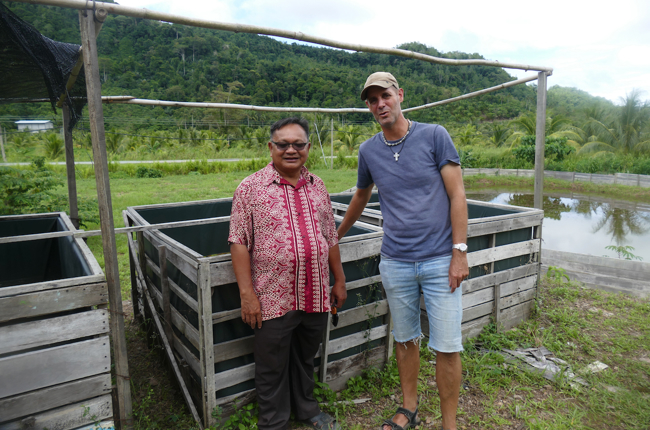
[124,198,392,426]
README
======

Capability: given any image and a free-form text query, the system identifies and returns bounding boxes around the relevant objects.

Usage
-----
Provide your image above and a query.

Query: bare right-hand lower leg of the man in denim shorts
[436,352,463,430]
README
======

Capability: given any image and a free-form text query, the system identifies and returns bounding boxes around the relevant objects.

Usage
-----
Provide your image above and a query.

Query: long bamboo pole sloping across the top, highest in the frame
[7,0,553,72]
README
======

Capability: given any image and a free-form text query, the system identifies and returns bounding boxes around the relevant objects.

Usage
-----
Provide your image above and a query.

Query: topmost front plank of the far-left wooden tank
[0,283,108,322]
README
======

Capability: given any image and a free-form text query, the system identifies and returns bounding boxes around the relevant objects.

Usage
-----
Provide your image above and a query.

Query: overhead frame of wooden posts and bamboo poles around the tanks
[5,0,553,428]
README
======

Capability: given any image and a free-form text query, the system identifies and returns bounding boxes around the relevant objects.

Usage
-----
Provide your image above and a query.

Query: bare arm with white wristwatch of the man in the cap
[440,163,469,293]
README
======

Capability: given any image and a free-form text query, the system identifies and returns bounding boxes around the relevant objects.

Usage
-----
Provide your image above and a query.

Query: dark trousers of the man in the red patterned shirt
[255,311,327,430]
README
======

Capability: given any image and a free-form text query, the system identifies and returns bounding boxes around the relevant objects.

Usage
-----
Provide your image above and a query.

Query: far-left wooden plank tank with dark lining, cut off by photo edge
[0,213,113,430]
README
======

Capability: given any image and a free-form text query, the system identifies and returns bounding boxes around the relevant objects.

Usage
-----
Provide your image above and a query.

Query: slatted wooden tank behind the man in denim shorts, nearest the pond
[331,193,544,341]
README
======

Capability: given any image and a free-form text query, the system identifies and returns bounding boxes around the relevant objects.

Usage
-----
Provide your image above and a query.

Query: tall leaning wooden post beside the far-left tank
[79,10,133,430]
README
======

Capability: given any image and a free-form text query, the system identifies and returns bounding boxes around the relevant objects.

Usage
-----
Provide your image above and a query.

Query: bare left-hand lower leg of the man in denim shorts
[384,339,420,430]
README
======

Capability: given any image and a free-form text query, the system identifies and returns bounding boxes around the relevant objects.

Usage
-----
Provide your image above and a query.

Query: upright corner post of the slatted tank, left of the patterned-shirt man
[197,261,217,427]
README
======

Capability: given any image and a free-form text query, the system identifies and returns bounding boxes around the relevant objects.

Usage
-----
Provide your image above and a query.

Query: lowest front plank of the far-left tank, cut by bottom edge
[0,394,113,430]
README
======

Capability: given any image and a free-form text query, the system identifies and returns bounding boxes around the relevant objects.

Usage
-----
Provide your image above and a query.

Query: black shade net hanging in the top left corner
[0,3,86,129]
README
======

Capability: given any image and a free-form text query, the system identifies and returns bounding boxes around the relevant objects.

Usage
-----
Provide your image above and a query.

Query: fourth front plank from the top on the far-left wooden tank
[0,373,111,422]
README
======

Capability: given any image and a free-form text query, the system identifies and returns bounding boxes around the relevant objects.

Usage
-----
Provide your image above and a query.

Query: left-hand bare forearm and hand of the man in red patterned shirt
[230,243,262,328]
